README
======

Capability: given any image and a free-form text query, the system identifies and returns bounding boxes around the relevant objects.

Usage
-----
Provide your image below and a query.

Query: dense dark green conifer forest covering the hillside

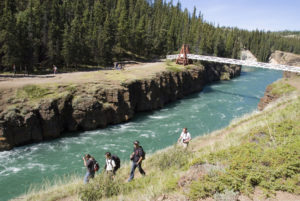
[0,0,300,71]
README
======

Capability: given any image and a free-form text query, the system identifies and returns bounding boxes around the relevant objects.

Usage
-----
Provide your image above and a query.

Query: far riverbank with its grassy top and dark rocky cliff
[0,62,241,150]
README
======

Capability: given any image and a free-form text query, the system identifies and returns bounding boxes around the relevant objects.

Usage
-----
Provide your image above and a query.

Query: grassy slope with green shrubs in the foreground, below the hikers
[18,88,300,201]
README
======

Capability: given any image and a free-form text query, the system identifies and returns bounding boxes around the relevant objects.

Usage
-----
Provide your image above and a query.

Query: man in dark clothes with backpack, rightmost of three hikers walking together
[128,140,146,182]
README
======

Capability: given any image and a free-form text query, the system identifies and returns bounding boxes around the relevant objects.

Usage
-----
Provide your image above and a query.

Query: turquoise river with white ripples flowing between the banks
[0,67,282,201]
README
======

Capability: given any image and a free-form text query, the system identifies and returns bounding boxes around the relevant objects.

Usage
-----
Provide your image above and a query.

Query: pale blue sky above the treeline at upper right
[169,0,300,31]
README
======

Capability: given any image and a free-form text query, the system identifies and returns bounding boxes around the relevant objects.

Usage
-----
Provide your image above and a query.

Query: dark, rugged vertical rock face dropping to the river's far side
[0,63,241,151]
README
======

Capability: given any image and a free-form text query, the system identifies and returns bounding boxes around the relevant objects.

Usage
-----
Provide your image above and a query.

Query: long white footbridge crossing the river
[167,54,300,73]
